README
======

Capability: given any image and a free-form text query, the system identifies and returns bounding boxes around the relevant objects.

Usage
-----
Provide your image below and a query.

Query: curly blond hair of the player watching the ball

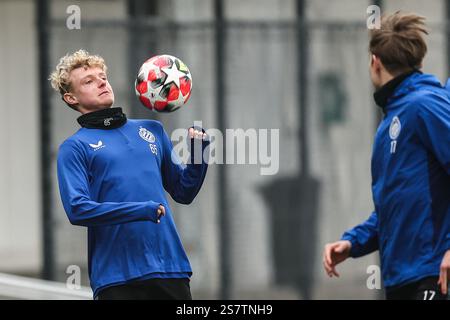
[49,49,107,96]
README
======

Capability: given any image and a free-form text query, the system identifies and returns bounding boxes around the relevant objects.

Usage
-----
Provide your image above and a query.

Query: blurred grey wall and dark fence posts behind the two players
[0,0,450,299]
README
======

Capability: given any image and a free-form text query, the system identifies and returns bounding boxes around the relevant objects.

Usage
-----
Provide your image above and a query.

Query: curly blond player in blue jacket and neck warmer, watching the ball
[50,50,209,300]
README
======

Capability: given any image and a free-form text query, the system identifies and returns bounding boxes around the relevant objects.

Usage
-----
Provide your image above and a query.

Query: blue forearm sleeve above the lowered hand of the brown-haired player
[341,212,378,258]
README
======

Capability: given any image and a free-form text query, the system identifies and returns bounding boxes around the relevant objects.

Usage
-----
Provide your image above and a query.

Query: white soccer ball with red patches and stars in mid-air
[134,54,192,112]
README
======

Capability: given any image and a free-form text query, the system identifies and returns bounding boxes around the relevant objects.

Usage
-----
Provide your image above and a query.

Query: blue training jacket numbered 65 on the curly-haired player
[57,119,208,296]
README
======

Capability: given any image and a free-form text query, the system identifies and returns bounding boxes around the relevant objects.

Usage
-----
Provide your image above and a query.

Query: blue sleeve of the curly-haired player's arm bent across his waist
[57,141,160,227]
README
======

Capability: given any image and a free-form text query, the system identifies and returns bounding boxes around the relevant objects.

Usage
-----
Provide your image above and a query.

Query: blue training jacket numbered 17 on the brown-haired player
[342,72,450,288]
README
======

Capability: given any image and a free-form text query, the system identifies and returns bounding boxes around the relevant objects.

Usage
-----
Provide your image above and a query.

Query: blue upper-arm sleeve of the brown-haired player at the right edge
[416,98,450,174]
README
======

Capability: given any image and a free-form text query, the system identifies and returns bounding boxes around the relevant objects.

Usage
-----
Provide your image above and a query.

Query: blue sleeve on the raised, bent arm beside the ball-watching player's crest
[161,126,209,204]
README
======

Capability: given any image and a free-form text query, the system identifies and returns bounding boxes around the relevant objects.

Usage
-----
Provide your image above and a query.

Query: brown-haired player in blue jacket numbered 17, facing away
[323,12,450,300]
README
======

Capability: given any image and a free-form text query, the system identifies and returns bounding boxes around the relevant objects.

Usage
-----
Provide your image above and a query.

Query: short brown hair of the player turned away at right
[369,11,428,74]
